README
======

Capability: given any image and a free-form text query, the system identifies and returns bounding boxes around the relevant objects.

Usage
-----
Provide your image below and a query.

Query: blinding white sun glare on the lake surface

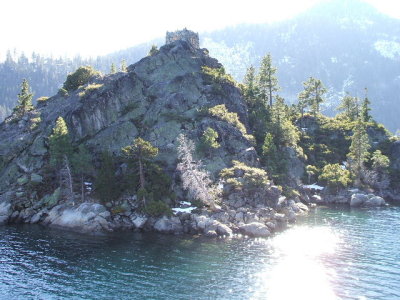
[251,227,339,300]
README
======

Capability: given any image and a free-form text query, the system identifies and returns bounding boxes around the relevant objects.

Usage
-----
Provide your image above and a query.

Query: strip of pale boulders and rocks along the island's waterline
[0,190,387,237]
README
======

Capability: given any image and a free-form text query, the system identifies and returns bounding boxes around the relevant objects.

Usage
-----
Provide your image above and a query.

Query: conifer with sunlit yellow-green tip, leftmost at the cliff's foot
[49,117,72,168]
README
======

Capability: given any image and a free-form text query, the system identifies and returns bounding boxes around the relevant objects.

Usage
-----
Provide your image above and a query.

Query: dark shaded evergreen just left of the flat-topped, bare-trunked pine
[94,152,123,203]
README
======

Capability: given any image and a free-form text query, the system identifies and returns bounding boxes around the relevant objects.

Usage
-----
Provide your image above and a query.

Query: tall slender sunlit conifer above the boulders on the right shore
[347,118,371,185]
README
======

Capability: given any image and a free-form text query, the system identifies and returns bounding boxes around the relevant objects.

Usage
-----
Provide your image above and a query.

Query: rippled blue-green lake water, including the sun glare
[0,207,400,299]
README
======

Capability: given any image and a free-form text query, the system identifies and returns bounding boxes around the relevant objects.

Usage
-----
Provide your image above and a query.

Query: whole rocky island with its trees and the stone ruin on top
[0,29,400,237]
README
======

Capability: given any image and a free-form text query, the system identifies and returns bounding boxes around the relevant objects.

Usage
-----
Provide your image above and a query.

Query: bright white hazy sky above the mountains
[0,0,400,59]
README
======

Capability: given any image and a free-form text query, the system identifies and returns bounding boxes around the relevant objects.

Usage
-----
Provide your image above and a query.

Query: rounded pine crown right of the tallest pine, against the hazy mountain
[299,77,327,117]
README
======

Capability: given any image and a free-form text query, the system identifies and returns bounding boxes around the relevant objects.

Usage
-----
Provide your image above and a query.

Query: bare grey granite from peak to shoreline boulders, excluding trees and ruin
[0,36,293,236]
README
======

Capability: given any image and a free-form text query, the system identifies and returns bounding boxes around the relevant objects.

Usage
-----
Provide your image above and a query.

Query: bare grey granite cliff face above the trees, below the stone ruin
[0,41,253,185]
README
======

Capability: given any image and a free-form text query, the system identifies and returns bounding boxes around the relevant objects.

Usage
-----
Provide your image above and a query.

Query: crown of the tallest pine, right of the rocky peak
[258,54,280,107]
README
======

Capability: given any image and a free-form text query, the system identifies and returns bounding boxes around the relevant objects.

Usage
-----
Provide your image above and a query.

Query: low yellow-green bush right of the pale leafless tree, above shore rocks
[220,160,269,190]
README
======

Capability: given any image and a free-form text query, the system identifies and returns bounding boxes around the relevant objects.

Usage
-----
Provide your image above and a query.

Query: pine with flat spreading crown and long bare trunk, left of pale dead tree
[122,138,158,206]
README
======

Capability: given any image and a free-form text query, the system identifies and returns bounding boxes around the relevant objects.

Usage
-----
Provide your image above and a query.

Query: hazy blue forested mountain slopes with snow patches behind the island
[0,0,400,132]
